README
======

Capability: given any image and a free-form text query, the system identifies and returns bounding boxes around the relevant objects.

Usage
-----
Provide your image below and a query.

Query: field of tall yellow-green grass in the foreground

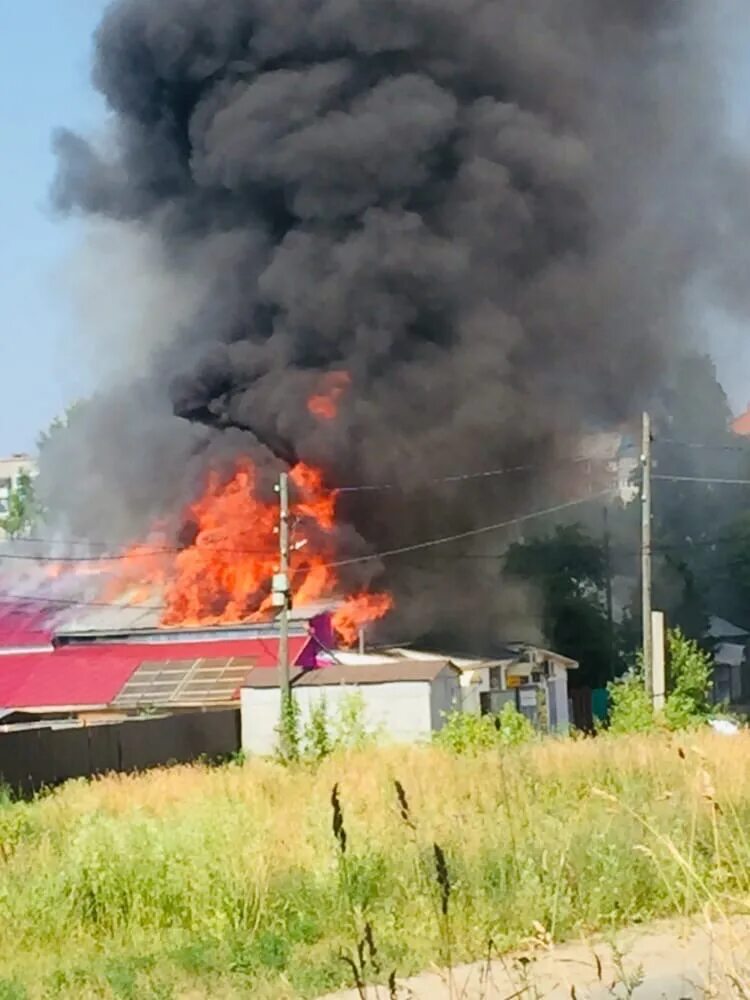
[0,735,750,1000]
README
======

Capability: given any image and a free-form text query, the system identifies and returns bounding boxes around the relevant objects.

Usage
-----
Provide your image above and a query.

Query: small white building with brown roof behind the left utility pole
[240,657,461,755]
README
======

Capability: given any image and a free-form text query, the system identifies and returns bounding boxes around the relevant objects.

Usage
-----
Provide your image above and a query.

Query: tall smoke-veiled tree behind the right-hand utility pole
[611,355,750,652]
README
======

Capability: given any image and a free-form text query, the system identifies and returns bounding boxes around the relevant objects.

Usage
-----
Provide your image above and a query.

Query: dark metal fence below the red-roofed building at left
[0,709,240,794]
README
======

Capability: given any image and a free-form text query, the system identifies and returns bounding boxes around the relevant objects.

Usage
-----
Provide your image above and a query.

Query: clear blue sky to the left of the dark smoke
[0,0,106,455]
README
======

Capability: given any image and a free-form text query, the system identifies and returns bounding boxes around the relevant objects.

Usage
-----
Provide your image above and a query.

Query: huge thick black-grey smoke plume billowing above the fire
[43,0,741,635]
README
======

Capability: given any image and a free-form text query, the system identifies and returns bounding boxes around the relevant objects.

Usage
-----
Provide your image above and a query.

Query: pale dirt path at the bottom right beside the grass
[321,918,750,1000]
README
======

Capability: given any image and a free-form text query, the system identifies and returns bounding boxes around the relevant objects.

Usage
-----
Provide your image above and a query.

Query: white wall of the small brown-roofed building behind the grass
[240,678,438,754]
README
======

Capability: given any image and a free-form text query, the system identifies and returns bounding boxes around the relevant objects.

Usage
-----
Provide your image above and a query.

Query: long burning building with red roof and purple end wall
[0,602,333,721]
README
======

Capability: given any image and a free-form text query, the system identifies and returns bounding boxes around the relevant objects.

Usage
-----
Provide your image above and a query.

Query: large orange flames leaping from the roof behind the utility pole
[99,459,391,644]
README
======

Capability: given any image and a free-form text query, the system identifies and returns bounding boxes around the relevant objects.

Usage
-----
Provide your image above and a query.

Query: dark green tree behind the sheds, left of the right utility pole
[505,525,613,687]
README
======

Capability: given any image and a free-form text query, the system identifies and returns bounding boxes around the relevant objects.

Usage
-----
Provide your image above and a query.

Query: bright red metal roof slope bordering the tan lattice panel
[0,636,314,708]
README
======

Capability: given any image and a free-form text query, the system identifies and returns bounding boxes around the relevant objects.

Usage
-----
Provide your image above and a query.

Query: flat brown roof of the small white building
[243,660,460,688]
